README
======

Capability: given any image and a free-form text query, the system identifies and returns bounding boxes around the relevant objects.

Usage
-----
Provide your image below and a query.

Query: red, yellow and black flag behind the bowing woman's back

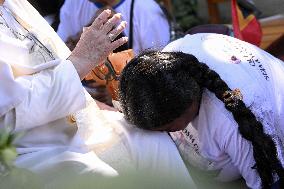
[232,0,262,46]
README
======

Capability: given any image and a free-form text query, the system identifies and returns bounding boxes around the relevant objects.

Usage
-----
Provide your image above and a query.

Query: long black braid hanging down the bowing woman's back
[180,52,284,188]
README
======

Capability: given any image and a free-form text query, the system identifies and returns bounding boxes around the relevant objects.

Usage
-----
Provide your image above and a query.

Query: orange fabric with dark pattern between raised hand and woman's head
[85,49,134,100]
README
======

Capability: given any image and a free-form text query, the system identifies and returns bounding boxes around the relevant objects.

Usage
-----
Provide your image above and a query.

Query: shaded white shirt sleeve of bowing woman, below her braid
[197,90,261,189]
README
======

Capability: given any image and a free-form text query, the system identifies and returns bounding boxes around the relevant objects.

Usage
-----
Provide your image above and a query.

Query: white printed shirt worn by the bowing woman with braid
[163,34,284,188]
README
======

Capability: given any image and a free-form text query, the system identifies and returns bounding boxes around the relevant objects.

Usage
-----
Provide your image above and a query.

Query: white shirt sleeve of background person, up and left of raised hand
[57,0,76,42]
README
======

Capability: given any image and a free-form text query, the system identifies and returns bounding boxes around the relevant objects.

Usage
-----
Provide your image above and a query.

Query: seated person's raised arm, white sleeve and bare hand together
[10,10,127,130]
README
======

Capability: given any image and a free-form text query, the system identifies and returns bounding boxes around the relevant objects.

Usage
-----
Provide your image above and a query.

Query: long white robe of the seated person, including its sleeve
[0,0,194,188]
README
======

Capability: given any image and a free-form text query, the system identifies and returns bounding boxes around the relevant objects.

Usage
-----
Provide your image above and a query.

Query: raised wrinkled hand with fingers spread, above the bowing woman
[68,10,128,79]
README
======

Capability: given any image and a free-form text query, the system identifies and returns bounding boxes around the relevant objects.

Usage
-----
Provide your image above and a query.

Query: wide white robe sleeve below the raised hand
[15,60,86,130]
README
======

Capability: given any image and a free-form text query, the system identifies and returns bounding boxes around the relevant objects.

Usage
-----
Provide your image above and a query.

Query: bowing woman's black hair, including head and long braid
[120,51,284,188]
